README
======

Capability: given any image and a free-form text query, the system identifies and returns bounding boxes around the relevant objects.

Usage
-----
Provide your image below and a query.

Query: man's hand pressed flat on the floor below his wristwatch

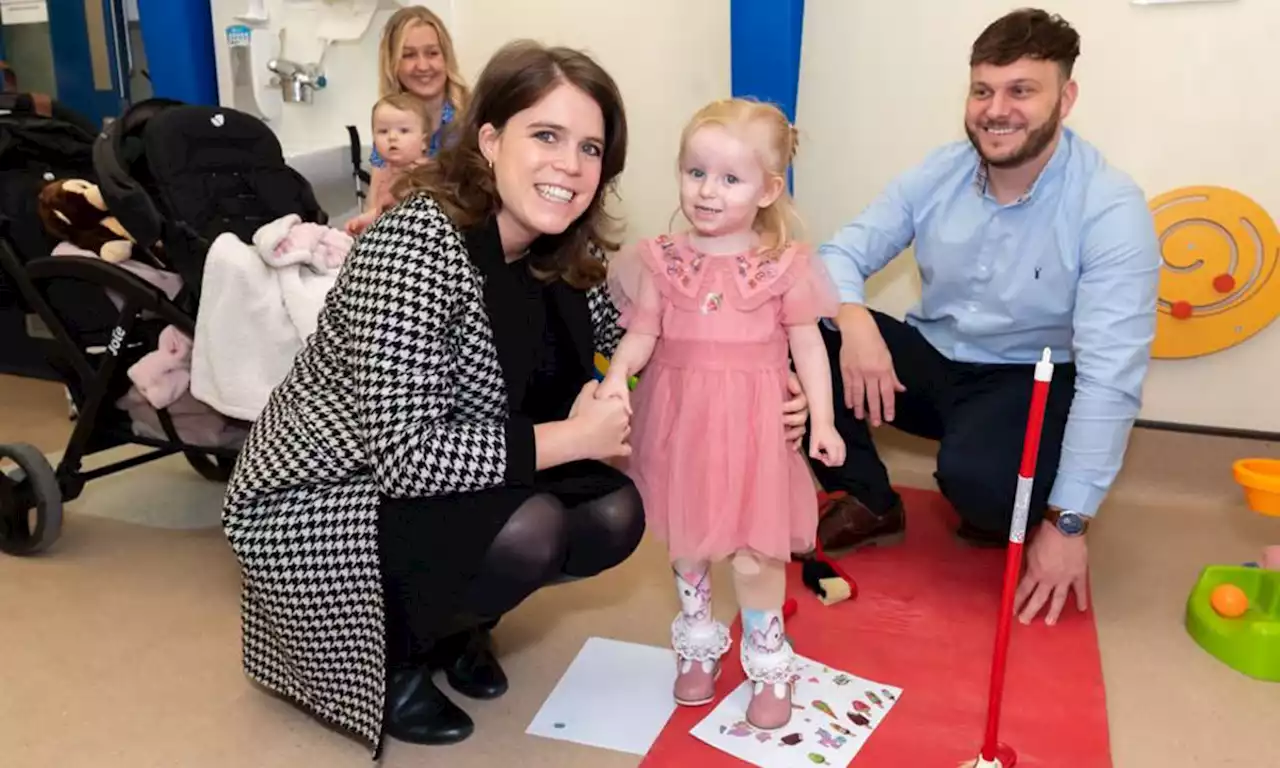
[1014,522,1089,626]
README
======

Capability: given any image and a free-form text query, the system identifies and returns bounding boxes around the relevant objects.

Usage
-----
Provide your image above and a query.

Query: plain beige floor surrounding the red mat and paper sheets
[0,378,1280,768]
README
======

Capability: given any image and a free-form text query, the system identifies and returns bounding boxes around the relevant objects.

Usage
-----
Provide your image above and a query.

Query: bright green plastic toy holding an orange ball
[1187,566,1280,682]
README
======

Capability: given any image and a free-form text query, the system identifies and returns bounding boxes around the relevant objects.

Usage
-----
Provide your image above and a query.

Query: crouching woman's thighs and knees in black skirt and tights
[379,476,644,668]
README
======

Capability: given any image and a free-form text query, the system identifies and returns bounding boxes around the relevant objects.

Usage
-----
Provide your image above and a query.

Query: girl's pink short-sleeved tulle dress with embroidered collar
[609,234,840,561]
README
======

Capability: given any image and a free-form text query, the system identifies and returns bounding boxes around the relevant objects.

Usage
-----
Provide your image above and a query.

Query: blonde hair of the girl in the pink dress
[678,97,800,259]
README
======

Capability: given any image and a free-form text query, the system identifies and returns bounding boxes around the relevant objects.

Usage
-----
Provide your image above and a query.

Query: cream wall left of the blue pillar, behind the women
[212,0,730,238]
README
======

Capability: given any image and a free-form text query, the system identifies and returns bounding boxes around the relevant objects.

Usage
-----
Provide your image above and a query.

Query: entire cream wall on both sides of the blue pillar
[214,0,1280,431]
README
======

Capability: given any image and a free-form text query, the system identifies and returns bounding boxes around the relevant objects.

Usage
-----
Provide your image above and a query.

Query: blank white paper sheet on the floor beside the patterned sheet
[525,637,676,755]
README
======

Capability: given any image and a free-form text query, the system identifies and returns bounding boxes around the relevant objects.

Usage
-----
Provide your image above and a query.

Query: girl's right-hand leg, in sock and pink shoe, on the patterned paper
[733,552,795,730]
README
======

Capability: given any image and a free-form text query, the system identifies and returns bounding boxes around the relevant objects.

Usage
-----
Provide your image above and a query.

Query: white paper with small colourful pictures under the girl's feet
[690,657,902,768]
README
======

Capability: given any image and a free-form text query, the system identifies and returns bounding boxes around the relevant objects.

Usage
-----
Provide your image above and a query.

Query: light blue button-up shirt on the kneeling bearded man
[819,129,1161,516]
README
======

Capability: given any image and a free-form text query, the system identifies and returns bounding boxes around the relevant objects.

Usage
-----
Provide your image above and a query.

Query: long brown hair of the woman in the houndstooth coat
[394,40,627,288]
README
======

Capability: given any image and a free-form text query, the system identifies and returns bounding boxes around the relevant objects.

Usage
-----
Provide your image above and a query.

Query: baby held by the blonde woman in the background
[347,92,430,237]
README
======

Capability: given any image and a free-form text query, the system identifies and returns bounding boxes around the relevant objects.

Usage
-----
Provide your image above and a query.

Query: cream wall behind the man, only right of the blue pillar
[796,0,1280,431]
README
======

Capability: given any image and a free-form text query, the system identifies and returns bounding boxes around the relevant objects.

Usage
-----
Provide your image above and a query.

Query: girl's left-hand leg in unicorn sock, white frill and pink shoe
[671,559,731,707]
